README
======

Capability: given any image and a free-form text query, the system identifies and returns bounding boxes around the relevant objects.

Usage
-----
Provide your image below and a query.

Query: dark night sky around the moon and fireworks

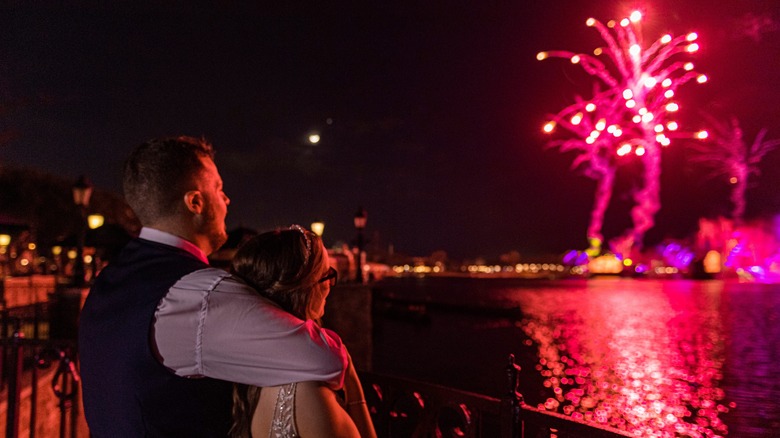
[0,0,780,257]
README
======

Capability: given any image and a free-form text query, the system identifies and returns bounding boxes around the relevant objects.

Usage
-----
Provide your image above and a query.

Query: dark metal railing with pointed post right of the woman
[360,355,632,438]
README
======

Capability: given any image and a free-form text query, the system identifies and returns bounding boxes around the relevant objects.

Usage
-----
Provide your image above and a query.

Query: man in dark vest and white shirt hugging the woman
[79,137,347,438]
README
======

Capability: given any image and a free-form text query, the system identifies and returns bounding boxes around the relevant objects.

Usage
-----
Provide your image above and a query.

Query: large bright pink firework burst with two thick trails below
[536,11,707,256]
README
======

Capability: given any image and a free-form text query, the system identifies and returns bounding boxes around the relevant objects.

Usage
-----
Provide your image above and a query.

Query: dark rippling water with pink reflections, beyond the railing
[373,277,780,437]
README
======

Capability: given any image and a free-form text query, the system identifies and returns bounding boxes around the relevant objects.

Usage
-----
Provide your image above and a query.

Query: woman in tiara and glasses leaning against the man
[231,225,376,438]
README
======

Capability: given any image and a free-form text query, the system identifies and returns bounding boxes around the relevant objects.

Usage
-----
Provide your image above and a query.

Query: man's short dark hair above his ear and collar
[123,136,214,225]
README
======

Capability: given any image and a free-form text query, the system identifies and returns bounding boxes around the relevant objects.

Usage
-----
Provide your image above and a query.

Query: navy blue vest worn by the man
[79,239,232,438]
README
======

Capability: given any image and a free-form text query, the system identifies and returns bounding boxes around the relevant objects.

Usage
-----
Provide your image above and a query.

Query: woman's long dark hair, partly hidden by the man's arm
[230,226,327,438]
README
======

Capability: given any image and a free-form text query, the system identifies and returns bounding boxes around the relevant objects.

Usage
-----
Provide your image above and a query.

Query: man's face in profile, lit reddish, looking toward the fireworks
[198,158,230,254]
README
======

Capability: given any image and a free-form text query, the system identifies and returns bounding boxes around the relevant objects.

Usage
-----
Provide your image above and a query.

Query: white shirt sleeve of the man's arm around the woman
[153,268,347,388]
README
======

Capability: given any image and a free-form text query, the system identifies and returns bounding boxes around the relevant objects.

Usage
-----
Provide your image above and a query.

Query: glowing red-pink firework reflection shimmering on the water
[522,280,735,437]
